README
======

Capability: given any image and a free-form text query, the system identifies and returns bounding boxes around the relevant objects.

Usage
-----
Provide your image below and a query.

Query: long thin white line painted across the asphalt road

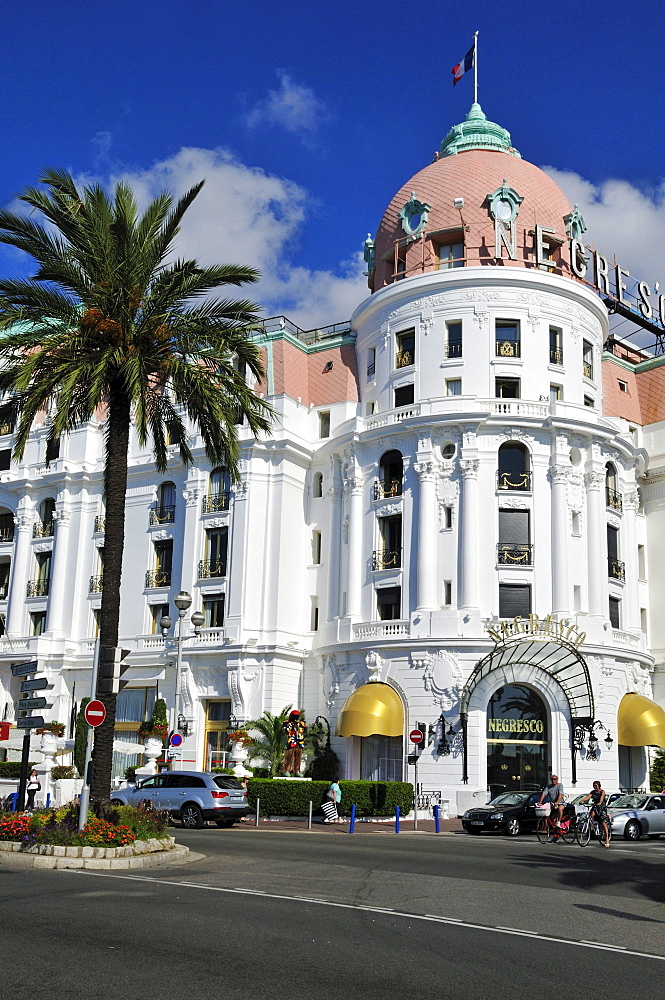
[65,868,665,962]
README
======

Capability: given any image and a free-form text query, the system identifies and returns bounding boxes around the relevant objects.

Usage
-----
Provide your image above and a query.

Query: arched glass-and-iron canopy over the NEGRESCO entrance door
[460,635,594,719]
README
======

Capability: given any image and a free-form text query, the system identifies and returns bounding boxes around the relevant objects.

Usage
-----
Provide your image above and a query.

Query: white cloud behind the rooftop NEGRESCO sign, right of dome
[545,167,665,287]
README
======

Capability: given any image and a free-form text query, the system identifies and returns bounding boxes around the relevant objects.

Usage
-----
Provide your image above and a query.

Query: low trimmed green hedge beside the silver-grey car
[247,778,413,816]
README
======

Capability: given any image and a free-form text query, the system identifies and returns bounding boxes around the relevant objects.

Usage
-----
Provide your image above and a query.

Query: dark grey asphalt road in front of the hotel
[0,827,665,1000]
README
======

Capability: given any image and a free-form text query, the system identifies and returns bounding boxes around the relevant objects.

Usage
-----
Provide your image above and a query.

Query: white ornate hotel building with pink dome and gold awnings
[0,105,665,811]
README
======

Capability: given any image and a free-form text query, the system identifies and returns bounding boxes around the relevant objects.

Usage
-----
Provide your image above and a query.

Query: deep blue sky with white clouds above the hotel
[0,0,665,326]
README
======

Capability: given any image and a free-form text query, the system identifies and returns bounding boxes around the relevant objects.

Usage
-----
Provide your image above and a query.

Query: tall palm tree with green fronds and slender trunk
[0,170,271,798]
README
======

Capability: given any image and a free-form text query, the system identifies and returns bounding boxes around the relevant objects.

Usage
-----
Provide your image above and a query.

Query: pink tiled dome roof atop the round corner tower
[374,149,571,290]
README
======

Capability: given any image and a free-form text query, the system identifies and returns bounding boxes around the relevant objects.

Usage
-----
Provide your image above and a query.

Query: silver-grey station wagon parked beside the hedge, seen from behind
[111,771,249,830]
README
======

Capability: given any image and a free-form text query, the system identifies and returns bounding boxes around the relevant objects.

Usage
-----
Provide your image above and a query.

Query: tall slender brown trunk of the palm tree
[90,383,131,799]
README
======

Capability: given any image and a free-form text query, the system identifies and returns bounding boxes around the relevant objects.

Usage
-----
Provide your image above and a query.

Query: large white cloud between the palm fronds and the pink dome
[111,148,367,329]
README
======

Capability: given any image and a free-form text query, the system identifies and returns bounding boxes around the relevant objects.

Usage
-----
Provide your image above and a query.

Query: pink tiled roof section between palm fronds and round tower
[272,339,359,406]
